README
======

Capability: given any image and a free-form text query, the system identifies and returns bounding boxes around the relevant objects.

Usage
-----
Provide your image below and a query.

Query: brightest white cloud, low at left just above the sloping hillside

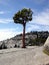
[0,28,21,41]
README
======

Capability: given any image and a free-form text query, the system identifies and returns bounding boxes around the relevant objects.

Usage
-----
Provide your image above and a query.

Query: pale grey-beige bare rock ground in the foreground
[0,46,49,65]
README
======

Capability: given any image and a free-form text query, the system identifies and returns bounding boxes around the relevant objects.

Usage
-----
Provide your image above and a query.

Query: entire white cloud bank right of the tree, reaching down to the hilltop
[27,9,49,31]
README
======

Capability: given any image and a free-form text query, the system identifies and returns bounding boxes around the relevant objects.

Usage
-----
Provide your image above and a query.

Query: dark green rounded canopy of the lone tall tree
[13,8,33,24]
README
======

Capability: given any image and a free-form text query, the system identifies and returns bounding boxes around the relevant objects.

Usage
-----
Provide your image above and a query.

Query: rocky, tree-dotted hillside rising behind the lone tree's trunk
[0,31,49,49]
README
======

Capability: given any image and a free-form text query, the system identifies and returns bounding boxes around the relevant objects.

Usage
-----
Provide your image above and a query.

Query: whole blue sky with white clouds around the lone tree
[0,0,49,41]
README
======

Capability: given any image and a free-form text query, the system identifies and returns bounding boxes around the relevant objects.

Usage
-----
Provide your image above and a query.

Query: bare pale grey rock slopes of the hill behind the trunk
[0,35,37,48]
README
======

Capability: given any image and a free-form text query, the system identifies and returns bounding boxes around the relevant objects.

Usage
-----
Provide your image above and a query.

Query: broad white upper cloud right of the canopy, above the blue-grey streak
[30,9,49,25]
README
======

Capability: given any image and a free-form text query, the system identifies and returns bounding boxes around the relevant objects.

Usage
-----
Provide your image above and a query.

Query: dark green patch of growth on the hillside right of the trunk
[28,38,46,46]
